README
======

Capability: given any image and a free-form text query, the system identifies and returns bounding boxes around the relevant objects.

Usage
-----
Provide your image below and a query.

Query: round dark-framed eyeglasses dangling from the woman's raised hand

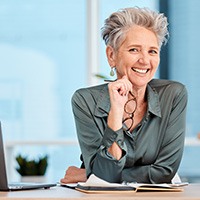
[122,92,137,131]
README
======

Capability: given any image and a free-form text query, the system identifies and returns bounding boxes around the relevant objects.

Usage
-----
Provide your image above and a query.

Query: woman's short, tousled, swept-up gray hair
[101,7,169,50]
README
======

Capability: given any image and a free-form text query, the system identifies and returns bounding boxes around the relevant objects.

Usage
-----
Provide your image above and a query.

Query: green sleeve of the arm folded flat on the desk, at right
[122,84,187,183]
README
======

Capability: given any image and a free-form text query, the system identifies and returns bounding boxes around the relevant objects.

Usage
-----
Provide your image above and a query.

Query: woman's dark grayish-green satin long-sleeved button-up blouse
[72,79,187,183]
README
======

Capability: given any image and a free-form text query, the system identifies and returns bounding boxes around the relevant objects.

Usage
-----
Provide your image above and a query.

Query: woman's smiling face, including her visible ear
[106,26,160,88]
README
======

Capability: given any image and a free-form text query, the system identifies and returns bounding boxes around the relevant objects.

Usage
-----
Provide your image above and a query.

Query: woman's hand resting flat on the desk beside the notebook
[60,166,87,183]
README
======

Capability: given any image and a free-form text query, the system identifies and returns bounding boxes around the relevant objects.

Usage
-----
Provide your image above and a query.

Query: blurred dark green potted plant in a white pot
[16,154,48,182]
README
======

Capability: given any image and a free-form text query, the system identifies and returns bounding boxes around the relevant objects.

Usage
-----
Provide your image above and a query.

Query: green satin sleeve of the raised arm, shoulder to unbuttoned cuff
[72,92,126,182]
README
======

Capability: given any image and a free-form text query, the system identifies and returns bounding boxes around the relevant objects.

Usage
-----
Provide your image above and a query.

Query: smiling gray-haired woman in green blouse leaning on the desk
[61,7,187,183]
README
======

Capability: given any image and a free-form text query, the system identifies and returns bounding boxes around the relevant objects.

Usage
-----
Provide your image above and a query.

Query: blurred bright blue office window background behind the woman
[0,0,200,182]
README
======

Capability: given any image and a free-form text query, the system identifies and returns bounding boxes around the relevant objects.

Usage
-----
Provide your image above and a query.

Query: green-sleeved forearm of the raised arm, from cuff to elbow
[90,127,126,182]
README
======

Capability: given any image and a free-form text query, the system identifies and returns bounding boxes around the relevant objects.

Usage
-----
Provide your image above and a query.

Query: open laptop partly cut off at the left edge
[0,123,57,191]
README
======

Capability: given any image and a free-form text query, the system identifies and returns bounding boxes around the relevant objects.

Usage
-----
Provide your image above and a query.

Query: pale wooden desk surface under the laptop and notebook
[0,184,200,200]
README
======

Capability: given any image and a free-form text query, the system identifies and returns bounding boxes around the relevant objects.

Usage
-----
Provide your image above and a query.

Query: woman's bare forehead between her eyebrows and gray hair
[121,26,159,48]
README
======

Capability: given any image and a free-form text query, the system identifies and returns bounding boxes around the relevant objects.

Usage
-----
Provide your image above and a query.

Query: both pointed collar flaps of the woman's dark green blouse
[94,84,161,117]
